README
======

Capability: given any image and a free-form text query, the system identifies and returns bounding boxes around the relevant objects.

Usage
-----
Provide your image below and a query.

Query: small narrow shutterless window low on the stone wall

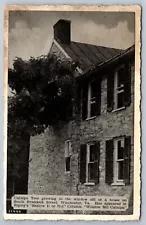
[65,140,72,172]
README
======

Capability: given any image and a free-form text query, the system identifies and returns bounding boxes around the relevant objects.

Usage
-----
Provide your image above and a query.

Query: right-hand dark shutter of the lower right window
[123,136,131,184]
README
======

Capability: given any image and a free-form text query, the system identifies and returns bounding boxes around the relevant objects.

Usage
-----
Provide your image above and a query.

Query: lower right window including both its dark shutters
[106,136,131,185]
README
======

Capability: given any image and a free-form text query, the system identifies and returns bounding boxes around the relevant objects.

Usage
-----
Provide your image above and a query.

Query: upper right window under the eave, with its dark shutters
[107,63,131,112]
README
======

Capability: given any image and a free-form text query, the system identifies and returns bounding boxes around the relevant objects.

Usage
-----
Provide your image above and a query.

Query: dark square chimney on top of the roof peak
[53,19,71,44]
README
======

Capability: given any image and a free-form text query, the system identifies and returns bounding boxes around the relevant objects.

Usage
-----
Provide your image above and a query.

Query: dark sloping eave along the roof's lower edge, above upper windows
[83,45,135,75]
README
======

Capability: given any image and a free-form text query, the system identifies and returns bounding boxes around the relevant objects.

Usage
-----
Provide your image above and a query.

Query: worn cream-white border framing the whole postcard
[4,5,141,221]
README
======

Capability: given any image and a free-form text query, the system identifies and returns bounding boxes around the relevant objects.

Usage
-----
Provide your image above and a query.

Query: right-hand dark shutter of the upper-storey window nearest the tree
[96,78,101,116]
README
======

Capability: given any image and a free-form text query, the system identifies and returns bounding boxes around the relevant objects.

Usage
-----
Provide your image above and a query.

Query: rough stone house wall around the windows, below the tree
[28,62,134,198]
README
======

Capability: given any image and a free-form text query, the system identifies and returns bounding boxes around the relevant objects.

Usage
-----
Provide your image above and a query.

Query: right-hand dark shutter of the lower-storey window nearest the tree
[94,141,100,184]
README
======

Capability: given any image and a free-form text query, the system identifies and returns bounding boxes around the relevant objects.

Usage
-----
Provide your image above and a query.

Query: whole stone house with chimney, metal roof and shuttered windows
[28,20,135,213]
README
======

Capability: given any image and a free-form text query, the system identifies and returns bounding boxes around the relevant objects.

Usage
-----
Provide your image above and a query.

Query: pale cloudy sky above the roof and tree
[8,11,135,67]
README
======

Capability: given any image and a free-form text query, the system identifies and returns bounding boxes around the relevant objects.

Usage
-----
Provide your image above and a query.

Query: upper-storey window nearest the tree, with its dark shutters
[82,78,101,120]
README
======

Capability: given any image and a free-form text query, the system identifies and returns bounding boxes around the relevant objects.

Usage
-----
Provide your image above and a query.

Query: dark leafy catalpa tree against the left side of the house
[8,54,77,177]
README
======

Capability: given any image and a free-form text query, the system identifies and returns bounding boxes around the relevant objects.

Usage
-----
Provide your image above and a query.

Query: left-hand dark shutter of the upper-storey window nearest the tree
[82,83,88,120]
